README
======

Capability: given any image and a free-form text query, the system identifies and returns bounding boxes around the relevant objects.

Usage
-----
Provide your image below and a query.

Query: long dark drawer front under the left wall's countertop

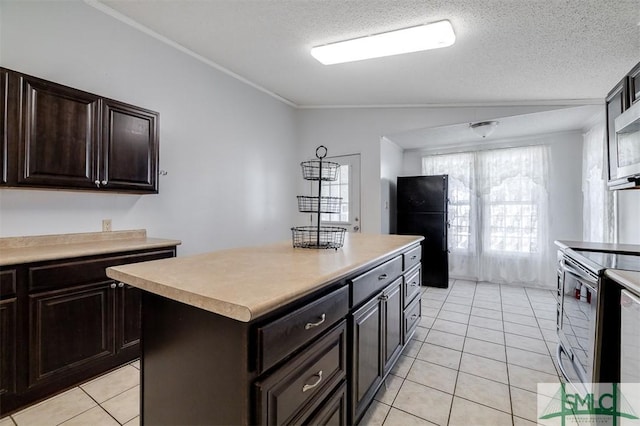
[28,248,175,292]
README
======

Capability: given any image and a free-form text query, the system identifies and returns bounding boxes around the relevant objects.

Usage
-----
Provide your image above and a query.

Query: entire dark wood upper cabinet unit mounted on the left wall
[0,68,159,194]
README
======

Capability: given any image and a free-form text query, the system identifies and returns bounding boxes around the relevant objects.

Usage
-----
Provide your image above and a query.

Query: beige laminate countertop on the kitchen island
[107,233,424,322]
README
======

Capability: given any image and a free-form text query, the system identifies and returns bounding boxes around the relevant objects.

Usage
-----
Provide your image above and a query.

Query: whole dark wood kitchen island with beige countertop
[107,234,423,425]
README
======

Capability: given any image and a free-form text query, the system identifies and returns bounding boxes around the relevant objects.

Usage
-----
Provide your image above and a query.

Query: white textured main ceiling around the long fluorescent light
[96,0,640,107]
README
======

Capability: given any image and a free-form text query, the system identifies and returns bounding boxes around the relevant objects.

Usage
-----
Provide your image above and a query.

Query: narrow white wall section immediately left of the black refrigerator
[380,137,403,234]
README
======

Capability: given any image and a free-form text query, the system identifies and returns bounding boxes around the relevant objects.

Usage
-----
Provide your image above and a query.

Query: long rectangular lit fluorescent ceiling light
[311,20,456,65]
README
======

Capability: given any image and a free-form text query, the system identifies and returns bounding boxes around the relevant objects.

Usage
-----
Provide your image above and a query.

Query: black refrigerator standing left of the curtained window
[396,175,449,288]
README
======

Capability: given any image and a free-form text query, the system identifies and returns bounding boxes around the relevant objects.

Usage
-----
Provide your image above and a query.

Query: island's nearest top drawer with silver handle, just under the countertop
[257,286,349,371]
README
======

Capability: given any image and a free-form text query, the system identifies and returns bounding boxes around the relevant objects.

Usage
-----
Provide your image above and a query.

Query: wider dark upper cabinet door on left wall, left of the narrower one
[16,75,100,188]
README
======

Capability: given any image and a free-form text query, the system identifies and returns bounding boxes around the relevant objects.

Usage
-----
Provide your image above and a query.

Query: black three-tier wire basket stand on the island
[291,145,347,250]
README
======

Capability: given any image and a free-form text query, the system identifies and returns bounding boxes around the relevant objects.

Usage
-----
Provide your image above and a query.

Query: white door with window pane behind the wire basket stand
[321,154,361,232]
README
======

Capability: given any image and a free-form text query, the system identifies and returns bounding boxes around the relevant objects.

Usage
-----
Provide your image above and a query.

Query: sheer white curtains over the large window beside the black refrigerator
[422,146,551,286]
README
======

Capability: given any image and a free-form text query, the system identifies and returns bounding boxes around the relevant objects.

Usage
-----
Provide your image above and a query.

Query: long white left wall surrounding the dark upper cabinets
[0,1,299,254]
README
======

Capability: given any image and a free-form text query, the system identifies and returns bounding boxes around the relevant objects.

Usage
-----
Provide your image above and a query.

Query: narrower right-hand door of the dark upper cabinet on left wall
[101,99,158,192]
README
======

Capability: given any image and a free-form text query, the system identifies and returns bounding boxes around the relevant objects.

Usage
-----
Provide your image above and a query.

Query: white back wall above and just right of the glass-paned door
[296,105,584,233]
